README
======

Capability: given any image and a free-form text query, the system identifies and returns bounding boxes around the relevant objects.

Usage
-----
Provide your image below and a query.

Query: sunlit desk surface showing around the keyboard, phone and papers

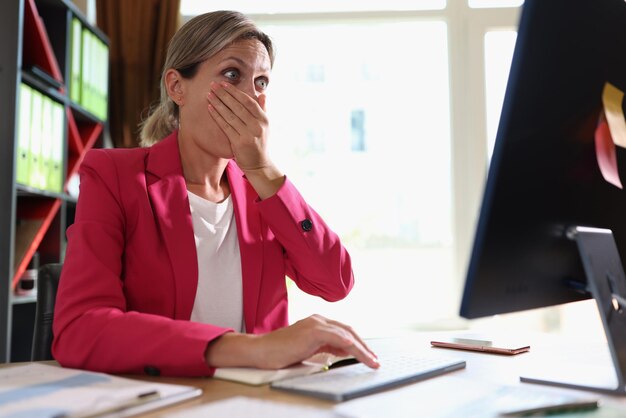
[4,333,626,418]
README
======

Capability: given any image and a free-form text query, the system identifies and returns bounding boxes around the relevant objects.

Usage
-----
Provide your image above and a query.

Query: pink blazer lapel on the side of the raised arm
[226,161,263,333]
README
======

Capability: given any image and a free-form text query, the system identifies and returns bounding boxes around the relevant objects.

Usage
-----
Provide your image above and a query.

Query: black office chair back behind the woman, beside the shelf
[31,263,63,361]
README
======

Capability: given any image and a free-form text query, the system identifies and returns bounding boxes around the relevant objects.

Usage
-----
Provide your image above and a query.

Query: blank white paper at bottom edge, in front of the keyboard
[164,396,347,418]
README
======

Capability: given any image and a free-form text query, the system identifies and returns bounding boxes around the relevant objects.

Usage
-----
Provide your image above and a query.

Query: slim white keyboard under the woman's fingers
[271,354,465,401]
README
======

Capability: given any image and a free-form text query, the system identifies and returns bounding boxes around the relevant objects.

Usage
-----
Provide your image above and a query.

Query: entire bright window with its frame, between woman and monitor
[181,0,519,335]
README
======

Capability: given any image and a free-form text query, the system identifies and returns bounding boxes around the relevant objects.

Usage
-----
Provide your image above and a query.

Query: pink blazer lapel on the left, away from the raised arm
[146,131,198,320]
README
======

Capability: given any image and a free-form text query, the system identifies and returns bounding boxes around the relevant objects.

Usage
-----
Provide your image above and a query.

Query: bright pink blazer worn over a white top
[52,132,354,376]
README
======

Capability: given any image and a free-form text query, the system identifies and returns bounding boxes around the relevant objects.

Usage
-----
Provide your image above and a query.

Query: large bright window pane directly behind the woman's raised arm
[263,21,453,328]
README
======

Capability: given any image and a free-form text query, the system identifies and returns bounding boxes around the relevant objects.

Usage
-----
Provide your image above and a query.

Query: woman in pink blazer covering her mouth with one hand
[53,12,378,376]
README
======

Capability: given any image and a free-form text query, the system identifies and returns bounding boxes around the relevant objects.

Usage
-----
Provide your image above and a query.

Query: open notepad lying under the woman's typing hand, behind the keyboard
[213,353,354,385]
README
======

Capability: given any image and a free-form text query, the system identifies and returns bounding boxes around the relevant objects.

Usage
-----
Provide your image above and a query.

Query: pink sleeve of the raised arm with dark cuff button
[257,179,354,302]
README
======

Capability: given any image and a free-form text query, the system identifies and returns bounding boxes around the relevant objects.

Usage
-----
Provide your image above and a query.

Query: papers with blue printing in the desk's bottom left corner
[0,363,202,418]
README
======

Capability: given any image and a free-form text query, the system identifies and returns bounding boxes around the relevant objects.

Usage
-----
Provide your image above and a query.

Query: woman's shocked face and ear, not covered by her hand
[170,39,271,158]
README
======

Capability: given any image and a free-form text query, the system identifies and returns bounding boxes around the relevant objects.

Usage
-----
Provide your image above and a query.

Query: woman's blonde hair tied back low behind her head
[139,11,274,147]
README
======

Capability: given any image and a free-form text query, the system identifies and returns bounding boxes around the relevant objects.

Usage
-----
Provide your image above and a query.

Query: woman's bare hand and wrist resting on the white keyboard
[206,315,379,369]
